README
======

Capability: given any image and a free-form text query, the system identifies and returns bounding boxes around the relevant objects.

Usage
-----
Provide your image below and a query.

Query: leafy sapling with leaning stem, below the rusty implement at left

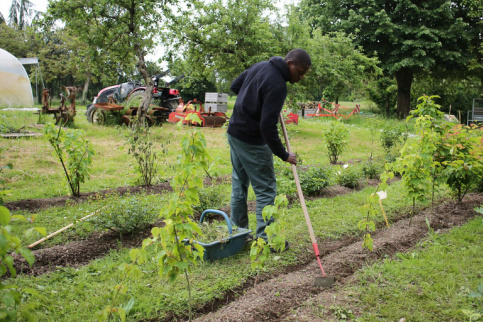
[44,123,94,197]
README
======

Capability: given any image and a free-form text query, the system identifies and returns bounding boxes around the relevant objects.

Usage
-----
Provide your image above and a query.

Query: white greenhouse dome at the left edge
[0,48,34,107]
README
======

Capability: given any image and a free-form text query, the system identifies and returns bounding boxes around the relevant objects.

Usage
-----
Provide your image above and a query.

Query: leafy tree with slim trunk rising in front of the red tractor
[49,0,177,114]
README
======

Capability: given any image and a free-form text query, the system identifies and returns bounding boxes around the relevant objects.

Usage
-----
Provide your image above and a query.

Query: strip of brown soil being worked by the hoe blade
[197,194,483,321]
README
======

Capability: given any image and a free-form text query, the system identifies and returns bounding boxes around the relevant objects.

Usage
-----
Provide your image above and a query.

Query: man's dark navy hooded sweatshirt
[228,57,290,161]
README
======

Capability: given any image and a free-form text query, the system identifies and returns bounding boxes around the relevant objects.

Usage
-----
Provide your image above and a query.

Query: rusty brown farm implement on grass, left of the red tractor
[39,86,81,124]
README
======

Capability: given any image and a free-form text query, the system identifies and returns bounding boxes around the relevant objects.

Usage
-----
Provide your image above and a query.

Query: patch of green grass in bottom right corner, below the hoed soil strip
[351,217,483,321]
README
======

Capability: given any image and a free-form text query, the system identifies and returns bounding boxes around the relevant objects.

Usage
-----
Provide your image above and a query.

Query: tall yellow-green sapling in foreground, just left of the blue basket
[131,113,210,320]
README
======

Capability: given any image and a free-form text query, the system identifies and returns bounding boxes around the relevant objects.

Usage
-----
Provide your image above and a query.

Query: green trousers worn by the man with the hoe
[228,134,277,239]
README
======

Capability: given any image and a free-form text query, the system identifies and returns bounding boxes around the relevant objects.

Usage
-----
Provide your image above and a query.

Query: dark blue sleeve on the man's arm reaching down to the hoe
[260,86,289,161]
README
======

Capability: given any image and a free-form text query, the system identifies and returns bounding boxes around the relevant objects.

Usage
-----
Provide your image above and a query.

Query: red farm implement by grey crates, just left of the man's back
[168,98,228,127]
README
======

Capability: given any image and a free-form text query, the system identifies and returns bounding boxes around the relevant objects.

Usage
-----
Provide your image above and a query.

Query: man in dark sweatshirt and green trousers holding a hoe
[227,49,312,248]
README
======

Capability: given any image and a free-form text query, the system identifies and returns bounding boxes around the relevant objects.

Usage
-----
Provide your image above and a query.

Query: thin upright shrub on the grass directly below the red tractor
[124,117,157,186]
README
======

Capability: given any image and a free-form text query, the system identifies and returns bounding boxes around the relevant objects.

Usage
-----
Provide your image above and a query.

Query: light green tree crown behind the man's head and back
[164,0,282,89]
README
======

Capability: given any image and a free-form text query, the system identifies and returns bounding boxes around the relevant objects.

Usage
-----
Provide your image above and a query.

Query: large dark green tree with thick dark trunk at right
[302,0,469,116]
